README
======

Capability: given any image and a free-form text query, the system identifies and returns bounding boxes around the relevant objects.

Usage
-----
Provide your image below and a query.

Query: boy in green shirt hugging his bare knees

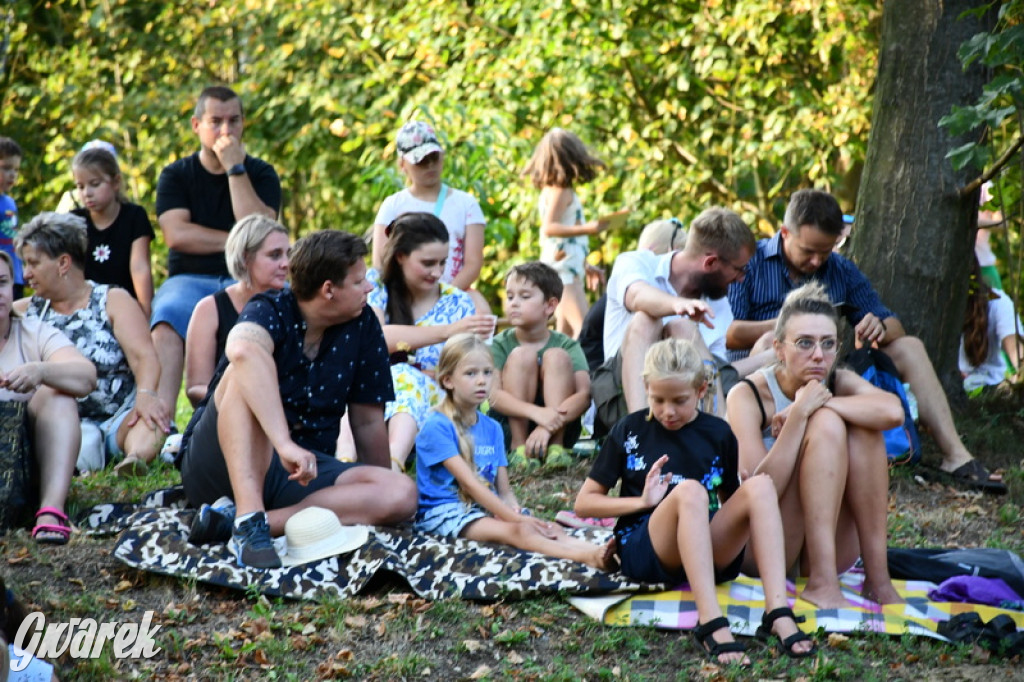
[490,262,590,467]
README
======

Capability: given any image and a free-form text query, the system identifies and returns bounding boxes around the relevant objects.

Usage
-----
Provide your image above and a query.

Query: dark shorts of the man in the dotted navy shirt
[181,399,361,509]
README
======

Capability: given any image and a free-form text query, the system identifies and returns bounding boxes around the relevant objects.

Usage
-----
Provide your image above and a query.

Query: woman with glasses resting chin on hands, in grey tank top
[727,283,904,608]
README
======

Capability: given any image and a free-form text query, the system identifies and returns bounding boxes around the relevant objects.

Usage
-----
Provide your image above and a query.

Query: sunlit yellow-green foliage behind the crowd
[2,0,880,299]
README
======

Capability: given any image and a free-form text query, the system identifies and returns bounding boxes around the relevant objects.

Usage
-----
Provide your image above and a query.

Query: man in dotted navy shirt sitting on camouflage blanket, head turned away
[181,230,416,567]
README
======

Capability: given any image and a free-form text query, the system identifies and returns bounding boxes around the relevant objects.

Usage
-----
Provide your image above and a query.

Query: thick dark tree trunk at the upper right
[853,0,991,404]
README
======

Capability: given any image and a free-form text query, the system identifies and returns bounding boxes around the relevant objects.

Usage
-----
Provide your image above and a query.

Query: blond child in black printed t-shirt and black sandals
[574,339,816,665]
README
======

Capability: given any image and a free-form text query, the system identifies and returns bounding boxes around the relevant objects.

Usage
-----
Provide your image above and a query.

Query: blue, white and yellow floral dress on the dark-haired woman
[367,270,476,427]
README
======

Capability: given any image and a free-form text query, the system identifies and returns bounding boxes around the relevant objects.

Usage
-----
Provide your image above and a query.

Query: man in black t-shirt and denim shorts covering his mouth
[150,86,281,413]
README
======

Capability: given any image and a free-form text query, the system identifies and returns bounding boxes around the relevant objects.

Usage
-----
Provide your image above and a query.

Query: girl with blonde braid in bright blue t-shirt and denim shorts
[416,334,613,570]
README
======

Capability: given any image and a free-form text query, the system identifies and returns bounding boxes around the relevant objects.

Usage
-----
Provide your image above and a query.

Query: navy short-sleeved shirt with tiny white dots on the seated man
[207,289,394,453]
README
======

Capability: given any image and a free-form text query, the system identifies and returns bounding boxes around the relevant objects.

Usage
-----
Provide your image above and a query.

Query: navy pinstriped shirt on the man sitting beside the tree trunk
[729,232,896,359]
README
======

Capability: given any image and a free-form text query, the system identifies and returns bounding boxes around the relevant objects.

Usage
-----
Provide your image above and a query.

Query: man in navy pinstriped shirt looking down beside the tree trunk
[726,189,1007,493]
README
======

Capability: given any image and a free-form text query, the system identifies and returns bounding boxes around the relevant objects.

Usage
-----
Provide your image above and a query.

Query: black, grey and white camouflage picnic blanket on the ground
[79,487,665,600]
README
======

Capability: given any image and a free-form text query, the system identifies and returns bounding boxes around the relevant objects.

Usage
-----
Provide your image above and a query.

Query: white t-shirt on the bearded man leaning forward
[604,250,732,359]
